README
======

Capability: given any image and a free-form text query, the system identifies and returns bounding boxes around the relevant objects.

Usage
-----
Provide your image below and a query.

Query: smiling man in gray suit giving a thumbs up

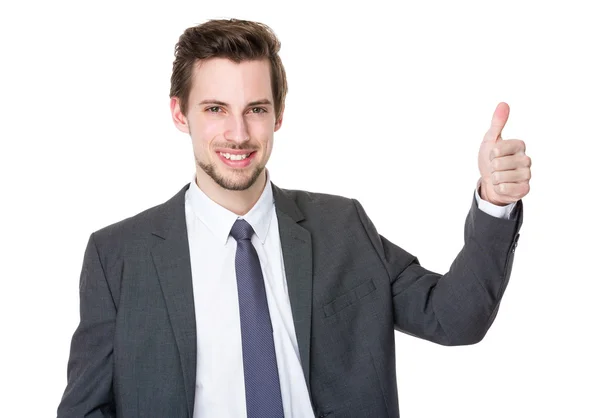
[58,20,531,418]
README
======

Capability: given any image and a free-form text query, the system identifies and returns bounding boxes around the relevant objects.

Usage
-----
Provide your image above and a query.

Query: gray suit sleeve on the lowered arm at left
[58,234,116,418]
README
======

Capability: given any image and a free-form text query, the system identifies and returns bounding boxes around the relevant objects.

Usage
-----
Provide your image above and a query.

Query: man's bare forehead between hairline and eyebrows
[192,58,273,103]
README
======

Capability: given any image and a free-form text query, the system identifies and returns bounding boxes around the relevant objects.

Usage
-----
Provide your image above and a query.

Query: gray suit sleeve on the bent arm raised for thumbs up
[354,191,523,345]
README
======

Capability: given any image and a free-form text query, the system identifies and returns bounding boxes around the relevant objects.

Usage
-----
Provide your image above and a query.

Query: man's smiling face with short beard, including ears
[171,58,281,190]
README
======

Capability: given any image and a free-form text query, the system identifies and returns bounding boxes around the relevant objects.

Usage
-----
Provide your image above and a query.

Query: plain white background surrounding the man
[0,0,600,418]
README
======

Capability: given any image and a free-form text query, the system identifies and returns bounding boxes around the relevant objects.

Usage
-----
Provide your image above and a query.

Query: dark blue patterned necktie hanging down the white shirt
[231,219,283,418]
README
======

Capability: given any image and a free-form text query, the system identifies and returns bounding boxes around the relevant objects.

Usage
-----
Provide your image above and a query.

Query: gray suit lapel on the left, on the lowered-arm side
[151,184,196,417]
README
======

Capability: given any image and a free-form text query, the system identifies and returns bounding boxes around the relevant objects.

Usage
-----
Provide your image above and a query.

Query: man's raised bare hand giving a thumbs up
[479,102,531,206]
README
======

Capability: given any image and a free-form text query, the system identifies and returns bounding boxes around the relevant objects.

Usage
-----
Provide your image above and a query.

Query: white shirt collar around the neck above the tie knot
[188,169,274,245]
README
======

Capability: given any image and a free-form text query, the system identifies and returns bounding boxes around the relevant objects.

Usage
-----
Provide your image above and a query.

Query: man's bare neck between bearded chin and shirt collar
[196,168,267,216]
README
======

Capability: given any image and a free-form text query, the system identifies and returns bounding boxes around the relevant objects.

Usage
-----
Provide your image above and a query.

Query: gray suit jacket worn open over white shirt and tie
[58,184,523,418]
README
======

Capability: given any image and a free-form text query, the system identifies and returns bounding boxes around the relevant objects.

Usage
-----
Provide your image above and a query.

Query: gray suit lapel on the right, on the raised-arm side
[271,183,313,394]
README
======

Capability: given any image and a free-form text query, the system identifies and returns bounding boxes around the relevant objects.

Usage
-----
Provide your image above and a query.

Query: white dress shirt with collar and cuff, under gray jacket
[185,170,514,418]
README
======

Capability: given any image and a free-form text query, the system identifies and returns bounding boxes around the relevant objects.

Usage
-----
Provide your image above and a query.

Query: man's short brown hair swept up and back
[169,19,287,119]
